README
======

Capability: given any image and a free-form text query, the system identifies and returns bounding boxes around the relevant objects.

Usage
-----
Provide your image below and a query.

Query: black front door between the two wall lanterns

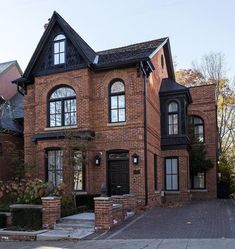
[108,154,129,196]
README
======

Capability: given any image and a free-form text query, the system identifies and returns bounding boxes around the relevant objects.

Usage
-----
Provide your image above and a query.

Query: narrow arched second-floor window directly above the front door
[109,80,126,123]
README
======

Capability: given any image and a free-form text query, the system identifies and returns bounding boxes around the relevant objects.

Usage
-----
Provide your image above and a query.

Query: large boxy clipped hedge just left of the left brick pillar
[12,206,42,231]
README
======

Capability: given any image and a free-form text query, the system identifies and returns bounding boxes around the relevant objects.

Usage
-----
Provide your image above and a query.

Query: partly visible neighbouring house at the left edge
[0,61,24,180]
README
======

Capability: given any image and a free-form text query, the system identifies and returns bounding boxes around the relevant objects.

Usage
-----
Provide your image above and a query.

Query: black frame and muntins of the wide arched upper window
[47,85,77,128]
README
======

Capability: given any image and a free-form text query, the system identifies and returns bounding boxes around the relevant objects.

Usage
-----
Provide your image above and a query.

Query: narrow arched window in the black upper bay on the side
[168,101,179,135]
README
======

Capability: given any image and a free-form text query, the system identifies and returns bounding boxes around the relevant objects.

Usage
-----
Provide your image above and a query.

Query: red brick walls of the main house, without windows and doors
[19,11,216,206]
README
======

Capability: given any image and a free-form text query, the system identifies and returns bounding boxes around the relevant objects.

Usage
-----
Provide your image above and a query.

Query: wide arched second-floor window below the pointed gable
[48,86,77,127]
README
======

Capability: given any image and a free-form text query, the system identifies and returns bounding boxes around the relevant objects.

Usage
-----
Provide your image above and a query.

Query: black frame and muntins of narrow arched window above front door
[109,79,126,124]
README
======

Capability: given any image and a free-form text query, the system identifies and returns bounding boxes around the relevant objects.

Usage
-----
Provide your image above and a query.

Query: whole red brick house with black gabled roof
[14,12,217,205]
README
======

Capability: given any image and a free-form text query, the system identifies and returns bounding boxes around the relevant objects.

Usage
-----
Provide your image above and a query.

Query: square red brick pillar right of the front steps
[94,197,113,230]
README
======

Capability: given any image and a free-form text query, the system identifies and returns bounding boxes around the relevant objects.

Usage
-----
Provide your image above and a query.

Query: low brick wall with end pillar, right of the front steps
[94,195,138,230]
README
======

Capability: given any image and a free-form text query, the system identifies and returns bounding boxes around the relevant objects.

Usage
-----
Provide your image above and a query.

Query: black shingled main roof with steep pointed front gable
[13,11,174,85]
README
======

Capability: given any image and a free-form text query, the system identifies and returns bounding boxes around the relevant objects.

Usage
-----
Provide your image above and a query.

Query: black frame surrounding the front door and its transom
[106,149,130,196]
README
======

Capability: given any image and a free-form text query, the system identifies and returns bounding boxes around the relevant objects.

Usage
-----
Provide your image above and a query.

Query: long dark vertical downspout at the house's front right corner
[140,61,148,206]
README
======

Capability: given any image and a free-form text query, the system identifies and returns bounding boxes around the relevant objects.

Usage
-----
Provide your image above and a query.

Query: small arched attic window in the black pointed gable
[54,34,66,65]
